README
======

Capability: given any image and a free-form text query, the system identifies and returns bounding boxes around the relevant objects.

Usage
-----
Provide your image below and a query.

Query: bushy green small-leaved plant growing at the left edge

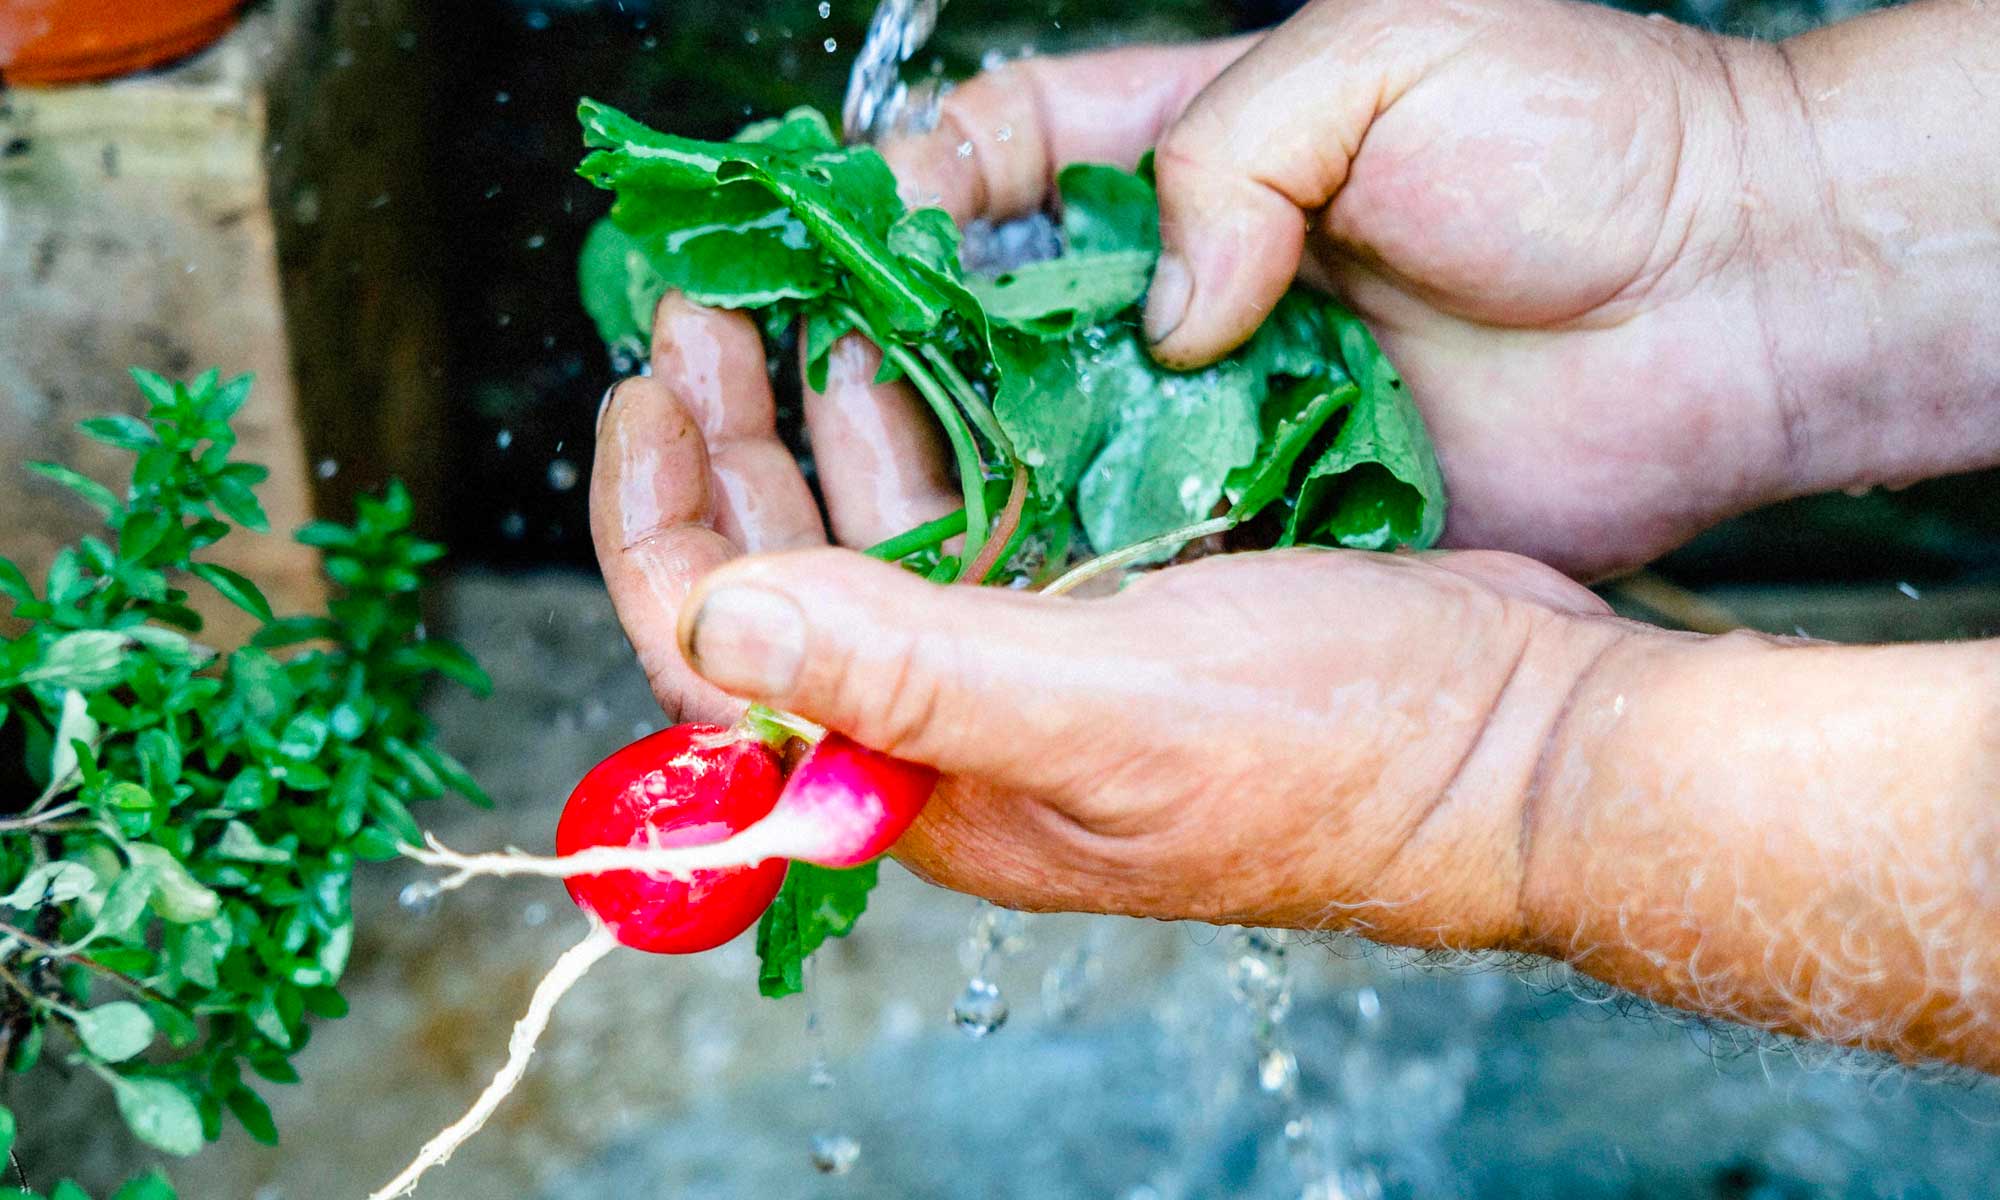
[0,370,490,1200]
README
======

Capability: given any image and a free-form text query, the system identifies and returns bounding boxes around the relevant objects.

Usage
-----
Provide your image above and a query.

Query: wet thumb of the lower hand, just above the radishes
[680,550,1122,788]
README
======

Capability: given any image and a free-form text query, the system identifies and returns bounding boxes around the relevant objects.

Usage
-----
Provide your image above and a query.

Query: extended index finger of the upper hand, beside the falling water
[882,34,1262,224]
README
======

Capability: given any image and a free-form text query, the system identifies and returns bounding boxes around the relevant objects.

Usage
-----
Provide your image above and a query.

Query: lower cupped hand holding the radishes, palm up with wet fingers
[592,288,1630,946]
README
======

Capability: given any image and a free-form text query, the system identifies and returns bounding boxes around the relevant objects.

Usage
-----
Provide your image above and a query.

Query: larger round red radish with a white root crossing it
[556,724,786,954]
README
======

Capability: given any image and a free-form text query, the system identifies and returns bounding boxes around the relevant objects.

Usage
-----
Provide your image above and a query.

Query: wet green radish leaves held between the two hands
[578,100,1444,996]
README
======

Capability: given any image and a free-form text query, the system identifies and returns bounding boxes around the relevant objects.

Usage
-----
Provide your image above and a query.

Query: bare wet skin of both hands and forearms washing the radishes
[592,0,2000,1070]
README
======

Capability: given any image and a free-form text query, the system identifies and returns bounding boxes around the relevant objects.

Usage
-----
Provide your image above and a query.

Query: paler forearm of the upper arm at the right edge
[1742,0,2000,492]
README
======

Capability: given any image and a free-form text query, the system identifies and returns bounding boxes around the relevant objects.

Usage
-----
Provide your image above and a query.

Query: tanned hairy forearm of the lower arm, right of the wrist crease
[1524,634,2000,1070]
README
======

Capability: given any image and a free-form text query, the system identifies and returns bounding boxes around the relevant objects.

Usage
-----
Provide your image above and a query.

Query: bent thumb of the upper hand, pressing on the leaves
[1146,4,1464,368]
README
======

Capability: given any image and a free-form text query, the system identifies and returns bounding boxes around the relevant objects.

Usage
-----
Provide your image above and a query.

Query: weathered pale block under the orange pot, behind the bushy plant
[0,4,324,644]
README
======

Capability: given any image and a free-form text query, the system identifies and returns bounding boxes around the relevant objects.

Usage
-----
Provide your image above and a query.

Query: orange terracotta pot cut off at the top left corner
[0,0,242,86]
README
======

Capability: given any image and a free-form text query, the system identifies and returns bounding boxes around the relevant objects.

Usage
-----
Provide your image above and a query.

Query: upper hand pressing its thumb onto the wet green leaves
[886,0,1812,576]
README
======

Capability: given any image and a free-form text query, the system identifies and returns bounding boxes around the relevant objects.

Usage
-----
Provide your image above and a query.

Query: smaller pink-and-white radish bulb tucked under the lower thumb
[758,734,938,866]
